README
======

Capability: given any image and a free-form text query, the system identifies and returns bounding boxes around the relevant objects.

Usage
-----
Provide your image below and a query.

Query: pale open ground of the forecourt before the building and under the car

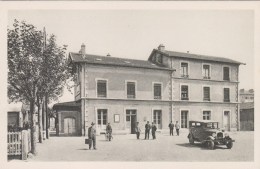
[23,132,254,162]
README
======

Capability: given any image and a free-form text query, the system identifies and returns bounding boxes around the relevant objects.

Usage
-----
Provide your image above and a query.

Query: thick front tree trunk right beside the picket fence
[30,101,37,155]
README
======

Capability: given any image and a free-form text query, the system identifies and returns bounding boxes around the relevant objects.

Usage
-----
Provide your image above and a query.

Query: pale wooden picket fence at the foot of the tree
[7,130,31,160]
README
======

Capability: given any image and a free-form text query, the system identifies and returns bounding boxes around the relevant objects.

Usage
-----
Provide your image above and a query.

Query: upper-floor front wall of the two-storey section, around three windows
[85,65,170,100]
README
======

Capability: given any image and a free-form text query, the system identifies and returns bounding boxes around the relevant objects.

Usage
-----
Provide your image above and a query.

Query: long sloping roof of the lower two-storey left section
[69,52,173,70]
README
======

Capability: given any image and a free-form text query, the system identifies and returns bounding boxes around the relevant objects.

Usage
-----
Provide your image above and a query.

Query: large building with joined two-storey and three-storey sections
[59,45,244,135]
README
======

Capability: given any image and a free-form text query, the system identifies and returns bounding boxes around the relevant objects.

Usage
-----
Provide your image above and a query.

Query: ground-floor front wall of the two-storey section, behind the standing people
[87,100,171,133]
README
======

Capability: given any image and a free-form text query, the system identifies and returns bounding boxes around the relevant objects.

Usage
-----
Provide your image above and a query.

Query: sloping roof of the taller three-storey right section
[153,49,245,64]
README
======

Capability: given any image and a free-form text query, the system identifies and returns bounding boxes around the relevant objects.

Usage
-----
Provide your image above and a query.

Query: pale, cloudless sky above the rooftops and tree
[8,9,254,102]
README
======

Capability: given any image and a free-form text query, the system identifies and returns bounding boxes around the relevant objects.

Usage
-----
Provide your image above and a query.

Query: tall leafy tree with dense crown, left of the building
[8,20,69,154]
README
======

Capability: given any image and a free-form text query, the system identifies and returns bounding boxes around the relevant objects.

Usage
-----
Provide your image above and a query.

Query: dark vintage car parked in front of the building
[188,120,235,149]
